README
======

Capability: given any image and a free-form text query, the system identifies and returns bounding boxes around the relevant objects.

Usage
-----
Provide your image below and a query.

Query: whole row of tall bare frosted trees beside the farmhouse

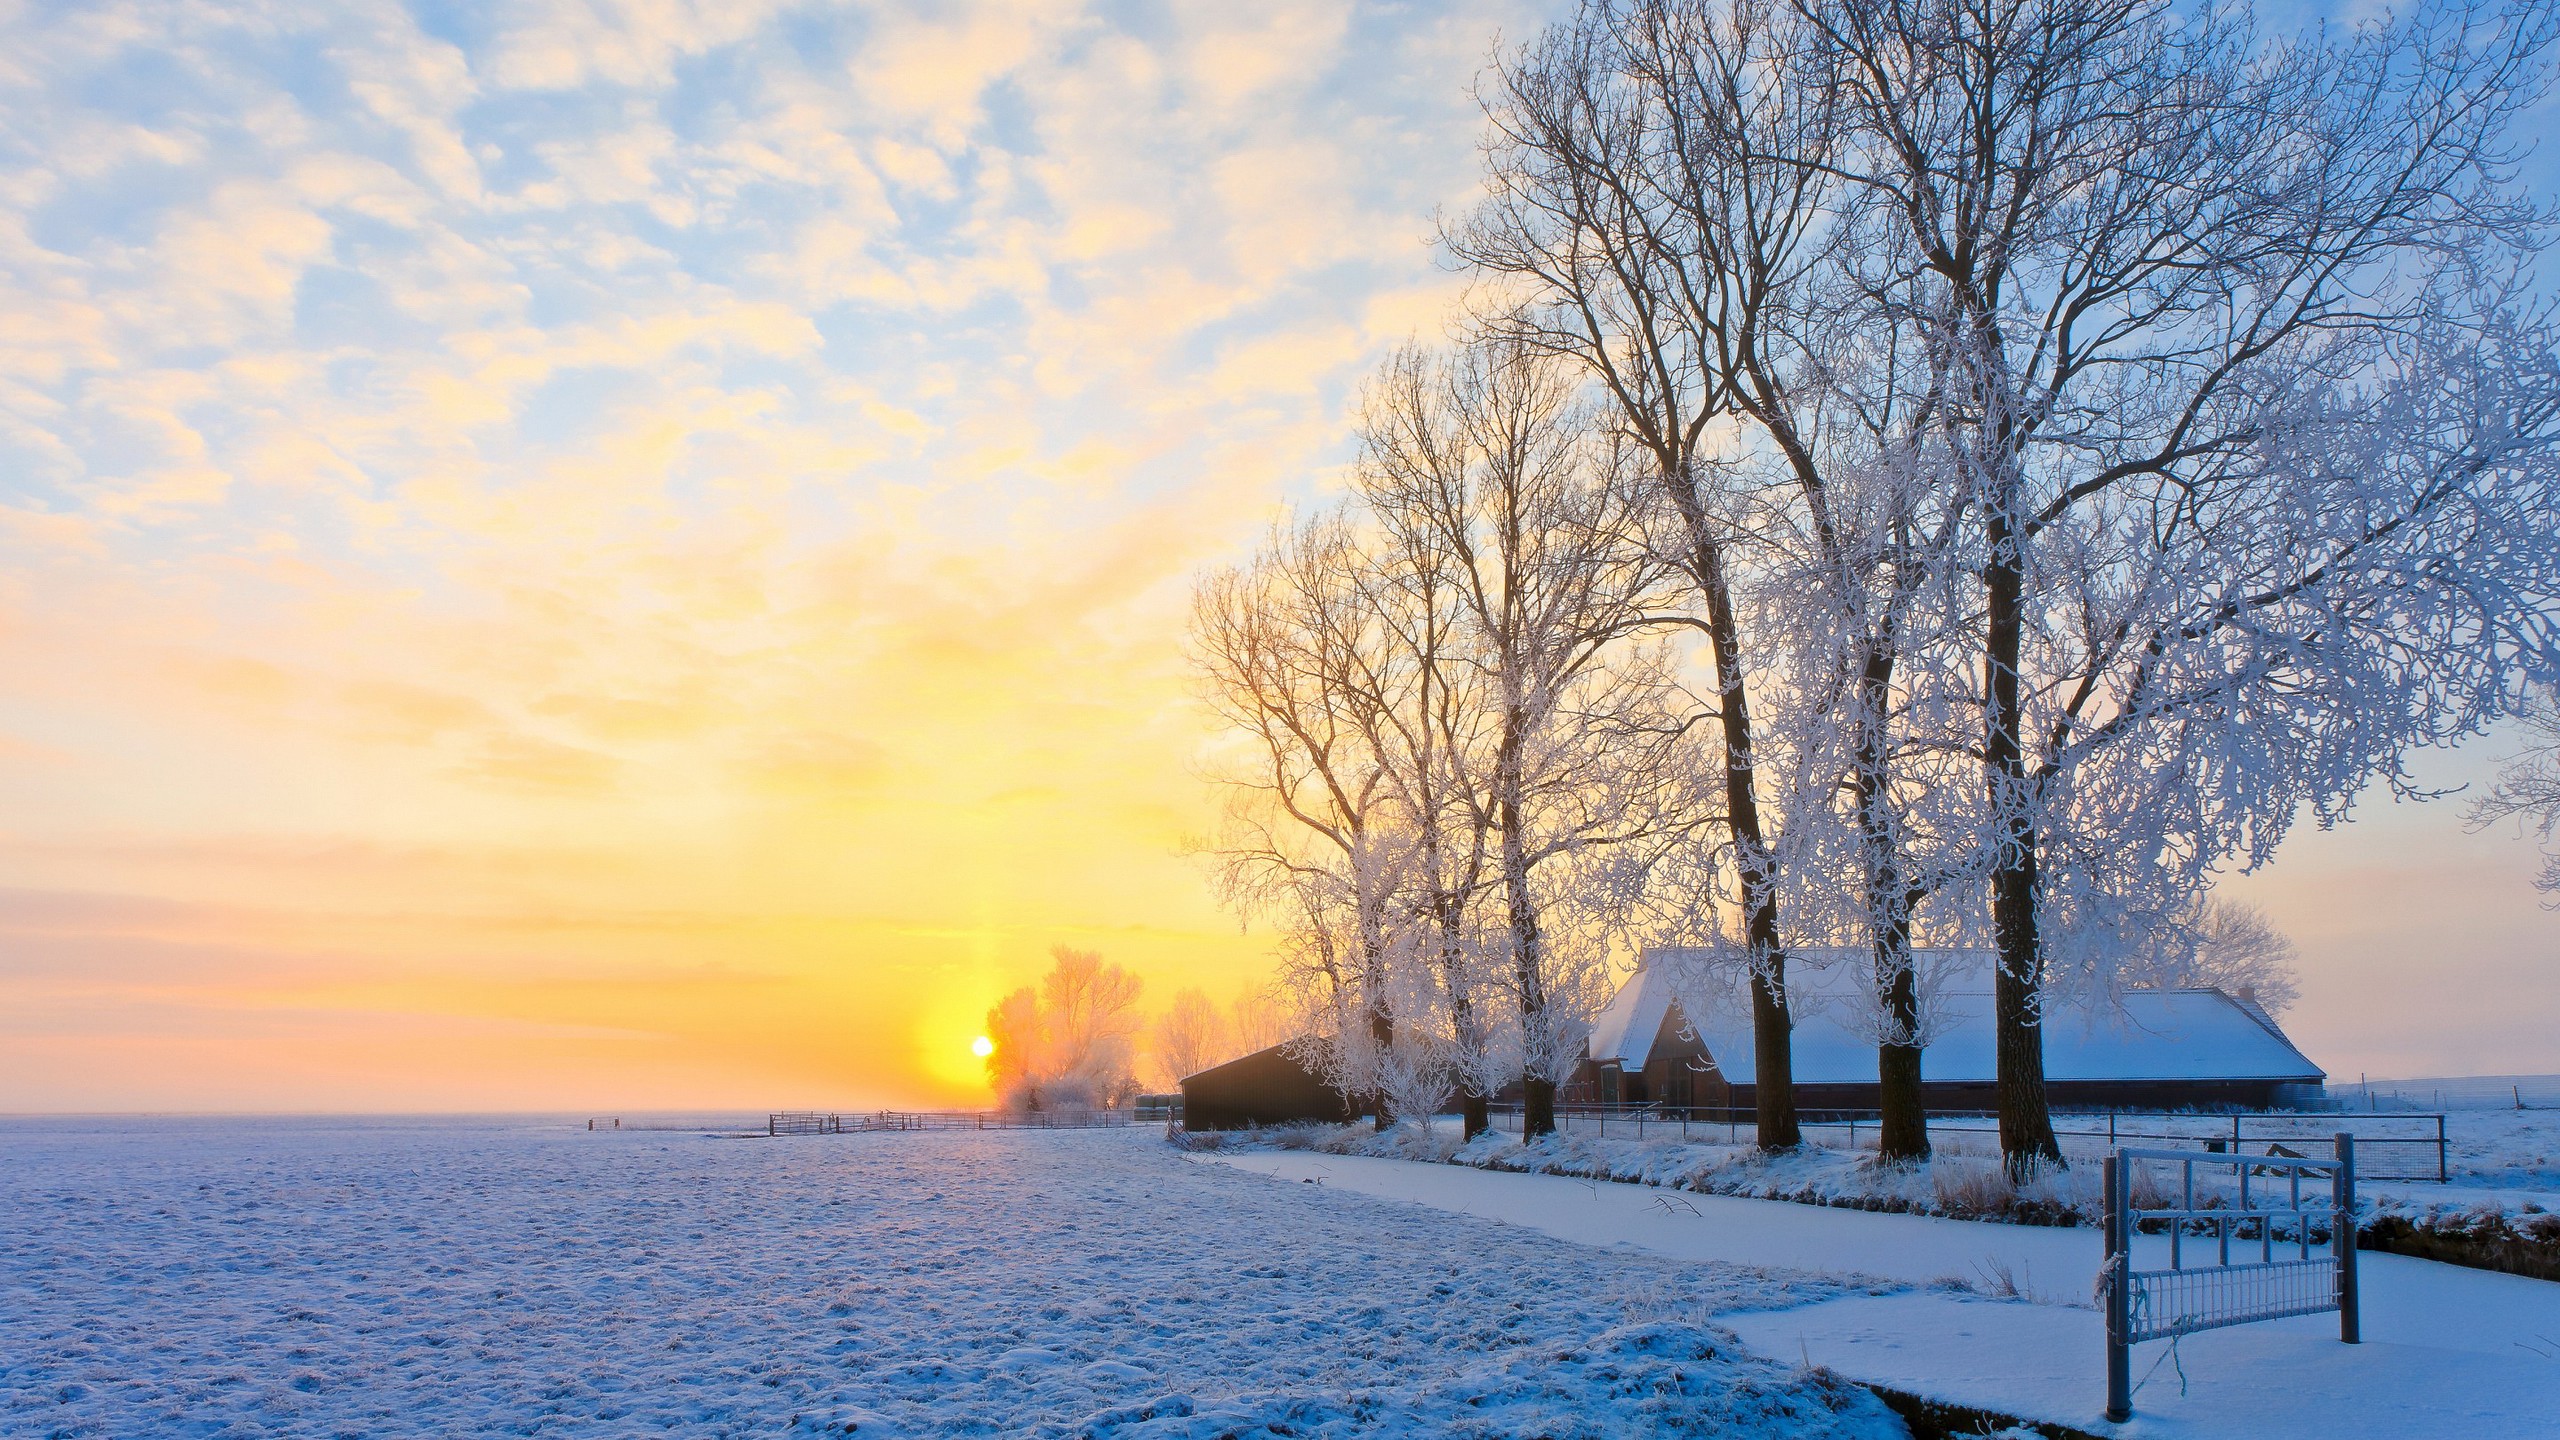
[1193,0,2560,1174]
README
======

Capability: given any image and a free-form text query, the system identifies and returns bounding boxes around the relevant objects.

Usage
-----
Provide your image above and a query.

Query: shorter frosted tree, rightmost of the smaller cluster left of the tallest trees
[1354,338,1713,1135]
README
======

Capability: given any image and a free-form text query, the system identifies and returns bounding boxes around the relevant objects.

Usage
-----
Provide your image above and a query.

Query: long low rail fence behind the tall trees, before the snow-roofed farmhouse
[1487,1104,2450,1181]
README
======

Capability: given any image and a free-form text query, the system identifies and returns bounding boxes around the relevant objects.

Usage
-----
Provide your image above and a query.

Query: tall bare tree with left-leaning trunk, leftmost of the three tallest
[1444,0,1830,1148]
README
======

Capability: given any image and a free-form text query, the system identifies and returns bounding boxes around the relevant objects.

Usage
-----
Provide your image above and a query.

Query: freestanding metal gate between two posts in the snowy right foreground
[2099,1135,2358,1420]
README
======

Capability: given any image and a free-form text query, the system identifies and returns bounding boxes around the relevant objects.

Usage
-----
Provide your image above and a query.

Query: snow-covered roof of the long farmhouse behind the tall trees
[1628,951,2324,1084]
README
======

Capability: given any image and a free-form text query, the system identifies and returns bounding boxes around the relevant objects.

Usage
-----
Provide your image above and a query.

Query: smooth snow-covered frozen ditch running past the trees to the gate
[1221,1150,2560,1440]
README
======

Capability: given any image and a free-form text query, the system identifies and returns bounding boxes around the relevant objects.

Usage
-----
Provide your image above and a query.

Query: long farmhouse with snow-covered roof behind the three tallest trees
[1562,951,2327,1109]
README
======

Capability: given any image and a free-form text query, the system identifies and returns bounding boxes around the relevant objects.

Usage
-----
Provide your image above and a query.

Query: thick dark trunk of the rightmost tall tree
[1984,499,2063,1181]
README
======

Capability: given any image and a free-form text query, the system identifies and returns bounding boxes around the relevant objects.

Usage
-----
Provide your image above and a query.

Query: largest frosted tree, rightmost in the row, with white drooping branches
[1797,0,2560,1174]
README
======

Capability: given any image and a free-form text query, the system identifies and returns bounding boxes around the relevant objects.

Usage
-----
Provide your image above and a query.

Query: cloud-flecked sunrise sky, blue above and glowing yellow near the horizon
[0,0,2560,1109]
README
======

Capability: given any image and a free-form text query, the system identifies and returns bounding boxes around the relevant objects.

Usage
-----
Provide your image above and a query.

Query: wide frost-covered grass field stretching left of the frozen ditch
[0,1120,1902,1437]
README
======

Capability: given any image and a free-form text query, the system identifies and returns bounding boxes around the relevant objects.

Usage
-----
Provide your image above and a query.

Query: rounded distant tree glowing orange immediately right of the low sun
[986,945,1139,1109]
